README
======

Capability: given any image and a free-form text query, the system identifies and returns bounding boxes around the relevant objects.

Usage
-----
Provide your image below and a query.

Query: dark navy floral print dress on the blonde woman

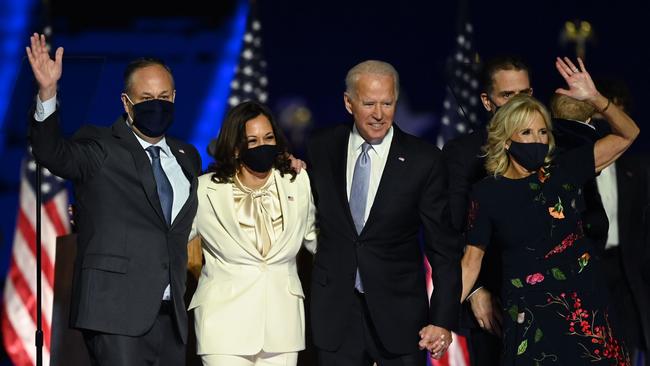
[467,145,629,366]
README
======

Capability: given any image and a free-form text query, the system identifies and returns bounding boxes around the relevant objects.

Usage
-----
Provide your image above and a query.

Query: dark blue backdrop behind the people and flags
[0,0,650,362]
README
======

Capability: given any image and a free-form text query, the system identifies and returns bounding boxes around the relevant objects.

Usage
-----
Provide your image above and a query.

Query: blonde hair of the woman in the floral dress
[483,94,555,176]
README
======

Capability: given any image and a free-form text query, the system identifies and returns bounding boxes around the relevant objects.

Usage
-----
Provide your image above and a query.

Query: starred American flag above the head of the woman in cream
[228,1,268,108]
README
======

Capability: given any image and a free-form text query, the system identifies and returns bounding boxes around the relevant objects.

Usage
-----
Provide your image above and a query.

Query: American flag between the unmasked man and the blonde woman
[436,23,481,147]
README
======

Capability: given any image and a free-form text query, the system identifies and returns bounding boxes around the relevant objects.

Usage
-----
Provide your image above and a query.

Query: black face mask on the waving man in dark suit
[129,99,174,137]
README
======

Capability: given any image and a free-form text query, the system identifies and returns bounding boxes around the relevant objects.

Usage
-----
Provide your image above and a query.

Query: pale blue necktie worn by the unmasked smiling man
[349,142,372,292]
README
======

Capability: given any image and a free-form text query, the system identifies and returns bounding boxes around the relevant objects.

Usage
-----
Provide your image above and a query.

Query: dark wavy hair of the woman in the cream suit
[207,101,296,183]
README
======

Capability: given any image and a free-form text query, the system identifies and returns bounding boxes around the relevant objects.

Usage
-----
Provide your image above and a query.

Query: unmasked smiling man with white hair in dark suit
[308,61,462,366]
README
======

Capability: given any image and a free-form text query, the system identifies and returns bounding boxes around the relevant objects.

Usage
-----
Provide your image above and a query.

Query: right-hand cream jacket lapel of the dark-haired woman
[266,170,298,259]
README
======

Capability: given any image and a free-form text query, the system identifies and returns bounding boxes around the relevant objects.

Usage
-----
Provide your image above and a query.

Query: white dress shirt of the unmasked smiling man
[345,126,393,222]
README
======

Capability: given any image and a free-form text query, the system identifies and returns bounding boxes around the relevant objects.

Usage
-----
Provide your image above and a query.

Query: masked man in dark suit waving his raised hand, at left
[27,34,201,365]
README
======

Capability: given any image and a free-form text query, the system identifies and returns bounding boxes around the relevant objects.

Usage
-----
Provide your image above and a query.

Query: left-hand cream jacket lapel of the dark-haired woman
[206,181,264,261]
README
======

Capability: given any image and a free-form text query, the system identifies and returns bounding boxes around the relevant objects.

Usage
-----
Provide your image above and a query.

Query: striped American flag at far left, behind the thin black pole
[2,150,70,366]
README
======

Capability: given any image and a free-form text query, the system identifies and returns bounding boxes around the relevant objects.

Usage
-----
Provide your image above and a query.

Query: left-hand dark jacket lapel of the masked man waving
[112,118,167,226]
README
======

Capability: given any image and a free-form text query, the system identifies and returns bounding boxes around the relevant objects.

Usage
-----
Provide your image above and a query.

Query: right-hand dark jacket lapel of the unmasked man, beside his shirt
[360,124,408,235]
